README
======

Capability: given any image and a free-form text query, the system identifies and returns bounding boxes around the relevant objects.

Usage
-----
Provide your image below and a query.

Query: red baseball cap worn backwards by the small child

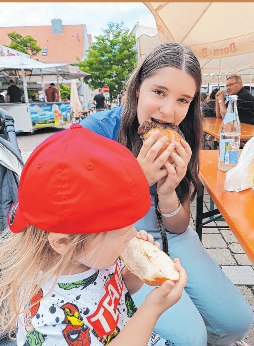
[8,124,151,234]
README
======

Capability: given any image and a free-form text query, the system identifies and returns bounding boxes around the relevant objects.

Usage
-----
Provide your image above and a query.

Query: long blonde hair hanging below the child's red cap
[0,226,99,335]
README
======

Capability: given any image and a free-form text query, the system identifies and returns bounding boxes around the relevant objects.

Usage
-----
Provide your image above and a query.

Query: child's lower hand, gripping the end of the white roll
[144,258,188,318]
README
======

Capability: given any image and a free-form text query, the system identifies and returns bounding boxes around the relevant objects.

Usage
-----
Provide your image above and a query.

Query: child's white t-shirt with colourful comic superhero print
[17,259,167,346]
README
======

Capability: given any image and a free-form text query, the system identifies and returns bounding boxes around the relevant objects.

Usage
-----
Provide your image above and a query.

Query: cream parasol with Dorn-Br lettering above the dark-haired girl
[144,2,254,83]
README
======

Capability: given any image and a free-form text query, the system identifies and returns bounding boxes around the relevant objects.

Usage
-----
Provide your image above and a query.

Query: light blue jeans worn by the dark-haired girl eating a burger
[133,198,253,346]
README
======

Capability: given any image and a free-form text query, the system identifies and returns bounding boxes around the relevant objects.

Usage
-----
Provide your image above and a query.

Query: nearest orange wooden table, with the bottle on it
[196,150,254,265]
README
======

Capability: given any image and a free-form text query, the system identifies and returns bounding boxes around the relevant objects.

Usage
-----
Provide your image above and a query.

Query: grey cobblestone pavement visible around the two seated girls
[0,125,254,346]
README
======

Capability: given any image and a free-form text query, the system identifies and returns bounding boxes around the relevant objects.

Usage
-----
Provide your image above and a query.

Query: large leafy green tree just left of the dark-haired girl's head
[77,23,137,101]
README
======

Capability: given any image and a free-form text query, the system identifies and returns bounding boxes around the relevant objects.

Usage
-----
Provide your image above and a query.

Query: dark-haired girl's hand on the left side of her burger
[137,131,179,186]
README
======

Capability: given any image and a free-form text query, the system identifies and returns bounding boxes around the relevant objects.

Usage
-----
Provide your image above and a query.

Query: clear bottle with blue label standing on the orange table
[218,95,241,172]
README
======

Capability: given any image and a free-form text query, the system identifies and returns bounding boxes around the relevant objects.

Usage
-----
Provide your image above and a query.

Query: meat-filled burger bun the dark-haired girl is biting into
[138,119,184,163]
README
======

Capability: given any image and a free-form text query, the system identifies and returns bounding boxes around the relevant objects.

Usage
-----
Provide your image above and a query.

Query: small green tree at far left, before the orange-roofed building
[8,31,41,56]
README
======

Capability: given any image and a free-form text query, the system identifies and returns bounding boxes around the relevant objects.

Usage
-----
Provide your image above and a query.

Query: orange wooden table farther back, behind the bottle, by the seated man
[203,118,254,142]
